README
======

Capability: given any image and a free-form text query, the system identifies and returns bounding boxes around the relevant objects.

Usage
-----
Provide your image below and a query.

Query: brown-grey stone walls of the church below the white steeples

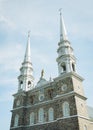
[11,73,92,130]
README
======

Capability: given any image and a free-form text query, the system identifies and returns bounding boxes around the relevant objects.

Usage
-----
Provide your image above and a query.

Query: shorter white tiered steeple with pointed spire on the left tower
[18,32,34,91]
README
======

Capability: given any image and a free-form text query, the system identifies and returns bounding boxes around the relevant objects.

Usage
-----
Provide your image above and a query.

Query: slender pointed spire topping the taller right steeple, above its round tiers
[59,9,68,41]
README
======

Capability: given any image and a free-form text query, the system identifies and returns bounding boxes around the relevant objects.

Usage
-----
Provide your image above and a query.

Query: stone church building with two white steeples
[10,12,93,130]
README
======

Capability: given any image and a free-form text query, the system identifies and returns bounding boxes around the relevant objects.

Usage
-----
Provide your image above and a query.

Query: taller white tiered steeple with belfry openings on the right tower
[57,9,76,75]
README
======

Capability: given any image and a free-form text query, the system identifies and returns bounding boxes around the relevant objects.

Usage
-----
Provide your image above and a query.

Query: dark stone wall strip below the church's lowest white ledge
[10,118,79,130]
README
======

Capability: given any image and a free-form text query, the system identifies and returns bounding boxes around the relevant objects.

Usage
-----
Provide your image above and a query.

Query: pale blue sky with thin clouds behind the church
[0,0,93,130]
